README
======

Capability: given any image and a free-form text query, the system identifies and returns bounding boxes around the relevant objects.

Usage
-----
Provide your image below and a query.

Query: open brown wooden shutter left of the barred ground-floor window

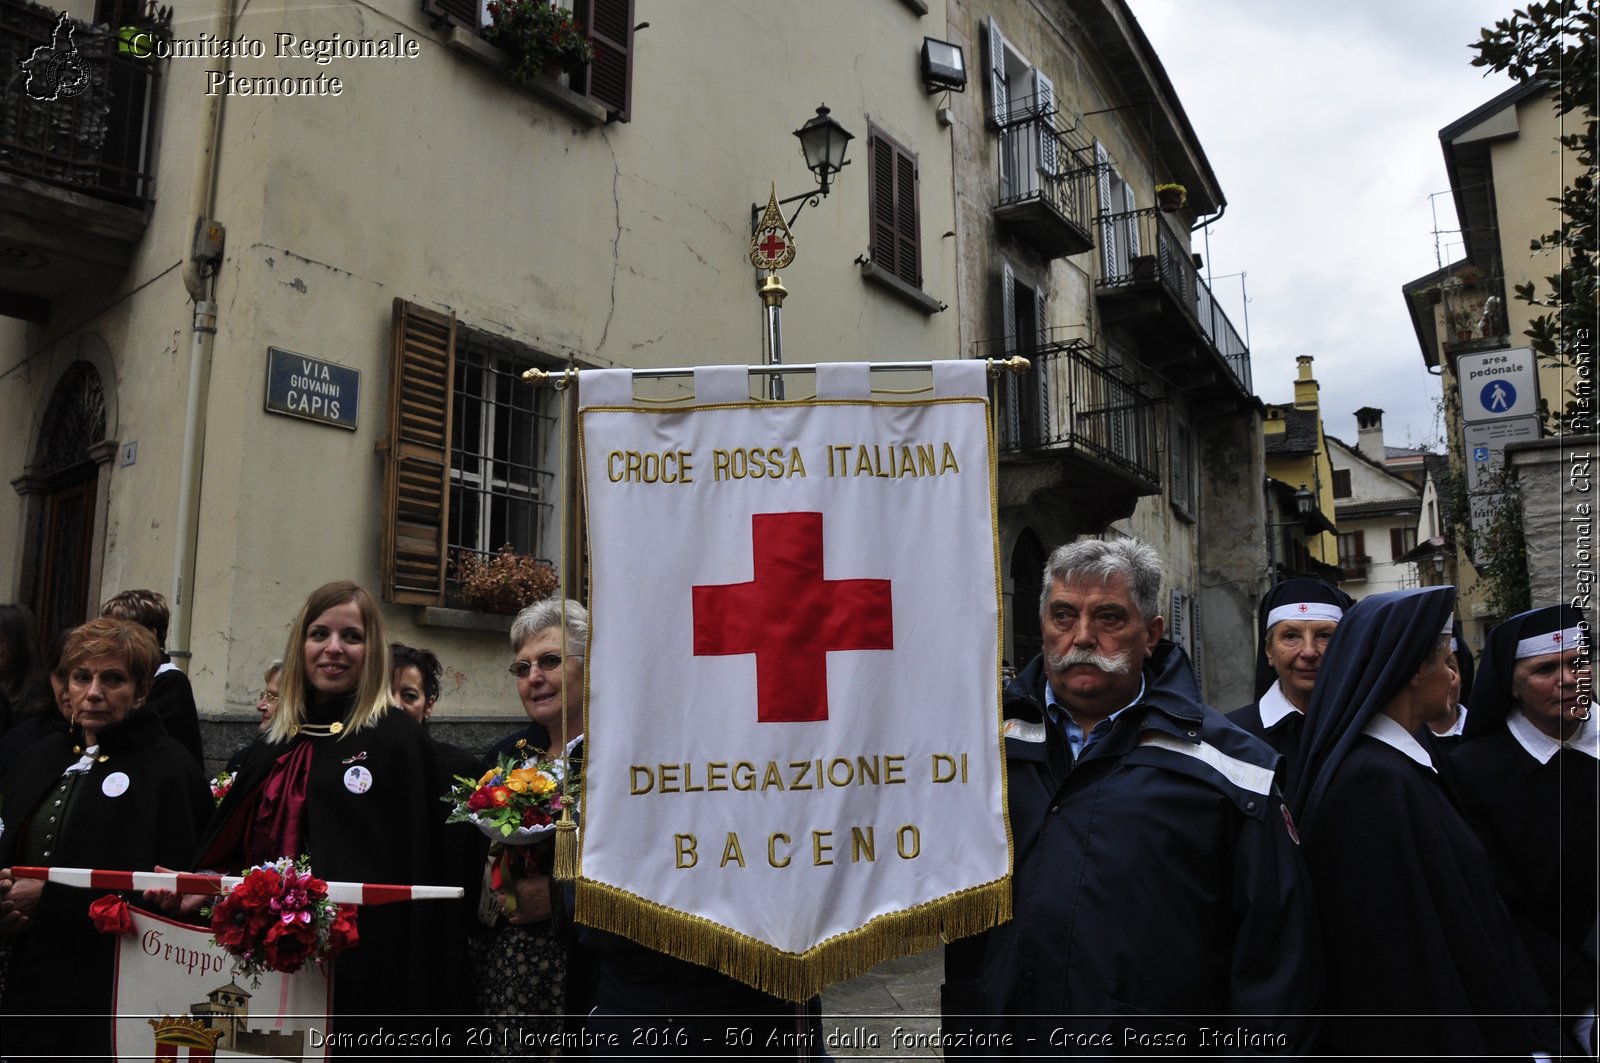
[382,299,456,605]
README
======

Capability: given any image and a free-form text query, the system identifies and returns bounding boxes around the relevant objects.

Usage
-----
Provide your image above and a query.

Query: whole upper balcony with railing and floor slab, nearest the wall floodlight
[995,107,1094,259]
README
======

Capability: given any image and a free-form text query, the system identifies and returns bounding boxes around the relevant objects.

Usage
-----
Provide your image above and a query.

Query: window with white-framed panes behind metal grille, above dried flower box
[450,336,557,576]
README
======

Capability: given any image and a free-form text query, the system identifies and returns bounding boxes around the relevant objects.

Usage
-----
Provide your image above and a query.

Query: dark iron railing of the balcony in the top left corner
[0,0,170,207]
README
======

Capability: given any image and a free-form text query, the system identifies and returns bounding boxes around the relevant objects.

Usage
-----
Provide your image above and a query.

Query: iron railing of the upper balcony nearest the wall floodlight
[998,106,1094,239]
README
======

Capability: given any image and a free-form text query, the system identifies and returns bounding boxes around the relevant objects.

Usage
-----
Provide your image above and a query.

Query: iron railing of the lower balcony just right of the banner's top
[1000,335,1162,490]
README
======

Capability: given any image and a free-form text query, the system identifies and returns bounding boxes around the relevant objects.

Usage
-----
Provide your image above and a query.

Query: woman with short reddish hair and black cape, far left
[0,618,211,1060]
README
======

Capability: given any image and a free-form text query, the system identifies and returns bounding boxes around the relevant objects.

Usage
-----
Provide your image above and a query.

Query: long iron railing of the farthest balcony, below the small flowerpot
[1094,207,1253,394]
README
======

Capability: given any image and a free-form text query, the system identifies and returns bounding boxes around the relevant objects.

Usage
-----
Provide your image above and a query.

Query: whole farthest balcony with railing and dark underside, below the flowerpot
[1094,208,1251,399]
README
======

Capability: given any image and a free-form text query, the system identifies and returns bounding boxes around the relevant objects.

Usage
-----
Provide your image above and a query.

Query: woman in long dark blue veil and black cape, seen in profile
[1291,588,1557,1058]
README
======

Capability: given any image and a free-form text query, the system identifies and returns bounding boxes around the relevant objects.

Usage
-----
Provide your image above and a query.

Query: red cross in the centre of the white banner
[693,512,894,724]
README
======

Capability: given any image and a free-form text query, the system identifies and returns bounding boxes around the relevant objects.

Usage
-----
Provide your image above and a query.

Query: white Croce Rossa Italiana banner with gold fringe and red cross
[576,362,1011,1001]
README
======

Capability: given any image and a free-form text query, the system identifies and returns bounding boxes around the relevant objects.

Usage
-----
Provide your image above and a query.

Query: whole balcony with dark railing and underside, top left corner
[0,0,171,320]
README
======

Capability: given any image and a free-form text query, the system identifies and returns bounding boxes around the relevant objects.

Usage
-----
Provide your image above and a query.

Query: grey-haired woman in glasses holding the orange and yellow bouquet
[470,599,589,1053]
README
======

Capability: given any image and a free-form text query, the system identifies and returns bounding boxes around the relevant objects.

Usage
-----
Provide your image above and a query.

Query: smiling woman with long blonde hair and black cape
[195,581,466,1029]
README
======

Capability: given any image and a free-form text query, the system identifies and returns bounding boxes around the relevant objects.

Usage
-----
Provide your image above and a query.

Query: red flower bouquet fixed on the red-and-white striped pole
[202,856,360,986]
